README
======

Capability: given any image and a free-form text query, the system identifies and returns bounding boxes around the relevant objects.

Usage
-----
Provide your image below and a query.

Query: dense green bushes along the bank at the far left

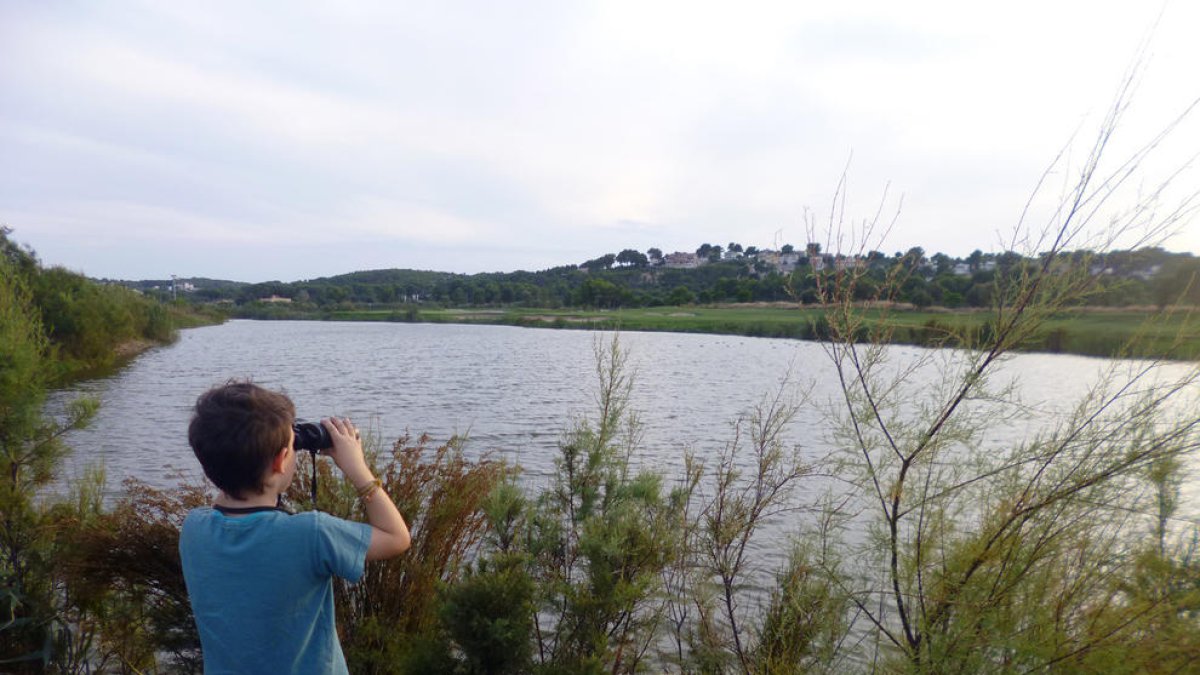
[0,227,222,671]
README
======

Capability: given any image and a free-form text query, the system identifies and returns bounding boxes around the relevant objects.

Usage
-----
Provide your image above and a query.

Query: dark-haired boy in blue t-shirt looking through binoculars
[179,382,410,675]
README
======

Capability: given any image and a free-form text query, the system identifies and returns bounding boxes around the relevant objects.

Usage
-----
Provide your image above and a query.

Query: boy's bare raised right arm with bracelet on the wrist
[322,417,412,560]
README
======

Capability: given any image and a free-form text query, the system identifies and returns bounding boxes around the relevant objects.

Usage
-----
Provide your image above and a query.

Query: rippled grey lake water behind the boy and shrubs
[42,321,1195,521]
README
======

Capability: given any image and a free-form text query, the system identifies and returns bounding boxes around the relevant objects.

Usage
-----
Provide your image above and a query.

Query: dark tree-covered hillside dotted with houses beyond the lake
[126,243,1200,316]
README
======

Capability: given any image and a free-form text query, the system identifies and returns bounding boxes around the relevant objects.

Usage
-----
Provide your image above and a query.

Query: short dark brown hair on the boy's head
[187,381,296,500]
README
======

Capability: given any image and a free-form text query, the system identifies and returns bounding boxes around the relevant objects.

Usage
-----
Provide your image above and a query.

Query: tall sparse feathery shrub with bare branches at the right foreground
[792,61,1200,673]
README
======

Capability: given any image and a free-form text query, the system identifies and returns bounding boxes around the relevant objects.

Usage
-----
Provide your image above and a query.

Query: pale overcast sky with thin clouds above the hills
[0,0,1200,281]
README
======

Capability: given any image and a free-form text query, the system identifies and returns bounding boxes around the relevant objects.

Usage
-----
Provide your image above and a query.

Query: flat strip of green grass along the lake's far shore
[324,306,1200,360]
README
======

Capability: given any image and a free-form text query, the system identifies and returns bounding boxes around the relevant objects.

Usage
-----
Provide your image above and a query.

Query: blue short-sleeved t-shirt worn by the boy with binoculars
[179,507,371,675]
